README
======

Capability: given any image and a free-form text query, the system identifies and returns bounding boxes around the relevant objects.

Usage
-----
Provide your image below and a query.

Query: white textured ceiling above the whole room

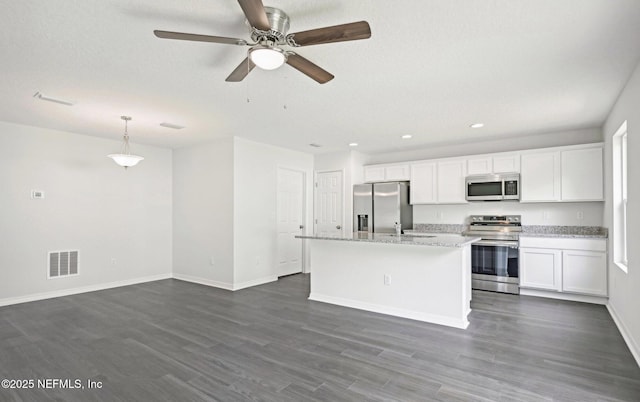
[0,0,640,153]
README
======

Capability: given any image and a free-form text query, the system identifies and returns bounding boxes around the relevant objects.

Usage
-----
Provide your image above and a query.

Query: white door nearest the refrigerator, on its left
[315,171,343,236]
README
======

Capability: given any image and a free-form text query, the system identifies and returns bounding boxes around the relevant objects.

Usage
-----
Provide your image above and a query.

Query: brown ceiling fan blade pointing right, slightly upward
[287,21,371,46]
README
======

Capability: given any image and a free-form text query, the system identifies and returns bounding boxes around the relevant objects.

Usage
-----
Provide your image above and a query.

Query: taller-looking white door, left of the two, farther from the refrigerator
[277,168,304,276]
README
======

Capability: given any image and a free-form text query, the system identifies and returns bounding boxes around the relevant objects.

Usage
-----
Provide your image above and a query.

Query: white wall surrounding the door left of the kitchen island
[233,137,313,289]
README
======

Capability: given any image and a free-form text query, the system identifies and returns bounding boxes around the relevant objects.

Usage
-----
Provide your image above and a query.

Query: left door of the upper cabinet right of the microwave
[520,152,560,202]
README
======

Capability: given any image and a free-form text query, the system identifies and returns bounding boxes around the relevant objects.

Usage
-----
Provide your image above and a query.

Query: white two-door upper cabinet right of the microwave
[520,144,604,202]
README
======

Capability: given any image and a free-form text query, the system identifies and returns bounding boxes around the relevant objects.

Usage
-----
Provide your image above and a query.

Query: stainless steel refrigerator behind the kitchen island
[353,182,413,233]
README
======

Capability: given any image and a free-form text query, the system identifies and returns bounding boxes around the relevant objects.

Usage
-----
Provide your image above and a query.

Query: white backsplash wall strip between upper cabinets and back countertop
[413,202,603,226]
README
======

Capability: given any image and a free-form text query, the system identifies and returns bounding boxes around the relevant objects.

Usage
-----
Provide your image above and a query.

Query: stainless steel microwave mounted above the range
[465,173,520,201]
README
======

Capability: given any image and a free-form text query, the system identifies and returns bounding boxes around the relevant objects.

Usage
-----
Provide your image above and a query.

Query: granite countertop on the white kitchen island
[296,232,480,247]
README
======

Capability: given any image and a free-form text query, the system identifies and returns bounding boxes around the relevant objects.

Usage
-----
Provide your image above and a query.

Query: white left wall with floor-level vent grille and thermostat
[0,122,172,304]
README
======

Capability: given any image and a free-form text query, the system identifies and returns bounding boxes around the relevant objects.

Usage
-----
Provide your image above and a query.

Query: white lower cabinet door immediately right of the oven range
[520,247,562,291]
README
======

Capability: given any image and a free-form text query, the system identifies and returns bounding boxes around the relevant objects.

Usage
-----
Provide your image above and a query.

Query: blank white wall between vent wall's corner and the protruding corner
[173,138,234,289]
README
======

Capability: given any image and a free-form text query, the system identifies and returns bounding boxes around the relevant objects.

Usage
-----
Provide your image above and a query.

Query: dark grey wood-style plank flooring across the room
[0,275,640,402]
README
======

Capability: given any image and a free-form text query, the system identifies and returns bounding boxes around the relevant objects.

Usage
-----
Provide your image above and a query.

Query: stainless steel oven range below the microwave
[463,215,522,294]
